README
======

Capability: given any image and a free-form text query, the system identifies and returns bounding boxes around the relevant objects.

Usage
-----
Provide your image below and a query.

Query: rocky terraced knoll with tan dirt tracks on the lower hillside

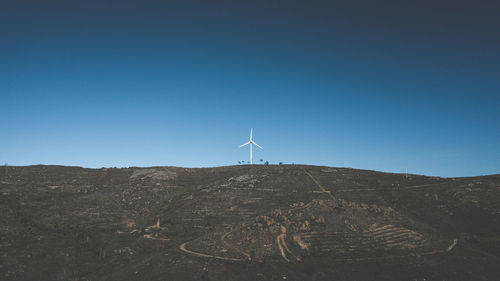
[186,190,432,262]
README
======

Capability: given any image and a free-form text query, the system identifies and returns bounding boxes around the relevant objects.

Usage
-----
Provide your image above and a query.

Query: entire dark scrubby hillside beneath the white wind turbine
[0,165,500,281]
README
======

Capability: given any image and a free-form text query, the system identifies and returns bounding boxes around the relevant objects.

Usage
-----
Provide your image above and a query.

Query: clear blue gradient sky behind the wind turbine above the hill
[0,0,500,176]
